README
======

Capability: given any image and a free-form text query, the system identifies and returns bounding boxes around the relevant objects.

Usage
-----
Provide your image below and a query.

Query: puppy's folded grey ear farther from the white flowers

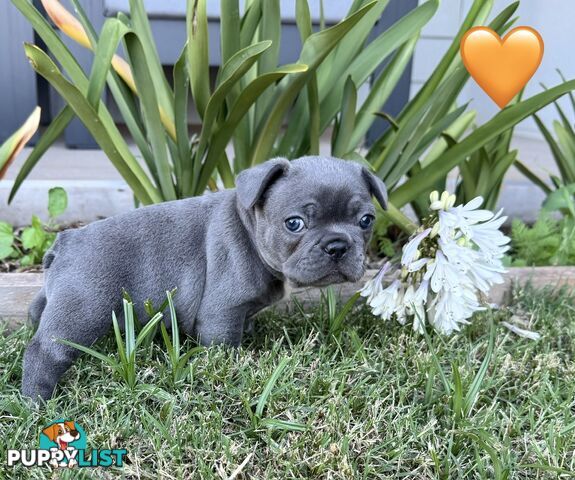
[236,158,289,210]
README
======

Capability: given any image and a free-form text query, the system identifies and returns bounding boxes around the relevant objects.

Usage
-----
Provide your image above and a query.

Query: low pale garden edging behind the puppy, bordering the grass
[0,267,575,330]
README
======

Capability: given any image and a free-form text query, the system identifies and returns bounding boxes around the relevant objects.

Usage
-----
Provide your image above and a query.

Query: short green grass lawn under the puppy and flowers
[0,289,575,479]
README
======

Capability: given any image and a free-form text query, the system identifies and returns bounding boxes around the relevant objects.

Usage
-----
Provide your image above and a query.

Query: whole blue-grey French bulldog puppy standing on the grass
[22,157,387,399]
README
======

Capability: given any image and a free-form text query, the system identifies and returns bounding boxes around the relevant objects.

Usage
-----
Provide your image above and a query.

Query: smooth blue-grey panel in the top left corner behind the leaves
[0,0,37,142]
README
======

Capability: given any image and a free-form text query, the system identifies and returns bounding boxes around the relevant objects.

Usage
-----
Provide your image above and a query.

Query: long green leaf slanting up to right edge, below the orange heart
[390,80,575,207]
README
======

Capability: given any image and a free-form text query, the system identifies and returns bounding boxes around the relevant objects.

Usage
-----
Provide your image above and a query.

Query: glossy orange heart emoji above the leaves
[460,27,543,108]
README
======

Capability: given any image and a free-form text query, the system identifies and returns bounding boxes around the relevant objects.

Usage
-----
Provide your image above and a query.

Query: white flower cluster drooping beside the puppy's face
[360,192,510,334]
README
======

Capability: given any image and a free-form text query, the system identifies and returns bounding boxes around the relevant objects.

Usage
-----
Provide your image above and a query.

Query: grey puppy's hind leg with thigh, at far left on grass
[22,290,113,400]
